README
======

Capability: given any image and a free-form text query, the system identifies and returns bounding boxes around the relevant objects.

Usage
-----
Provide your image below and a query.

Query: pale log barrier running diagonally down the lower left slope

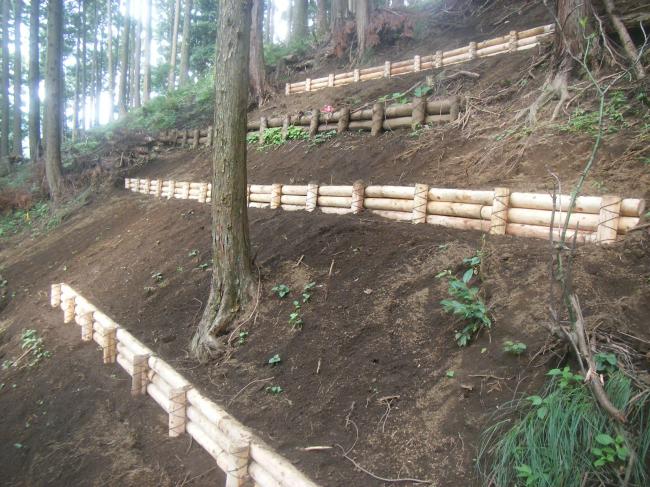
[50,284,317,487]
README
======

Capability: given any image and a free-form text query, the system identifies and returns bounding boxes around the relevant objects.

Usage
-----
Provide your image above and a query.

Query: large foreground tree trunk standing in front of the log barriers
[192,0,254,359]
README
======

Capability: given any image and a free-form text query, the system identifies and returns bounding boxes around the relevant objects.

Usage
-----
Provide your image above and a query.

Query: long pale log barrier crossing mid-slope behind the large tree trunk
[124,178,645,244]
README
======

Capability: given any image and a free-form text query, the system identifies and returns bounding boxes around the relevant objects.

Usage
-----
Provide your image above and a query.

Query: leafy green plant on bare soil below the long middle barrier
[436,253,492,347]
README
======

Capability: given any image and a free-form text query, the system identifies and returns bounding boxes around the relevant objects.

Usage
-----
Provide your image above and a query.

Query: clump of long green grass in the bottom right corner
[477,367,650,487]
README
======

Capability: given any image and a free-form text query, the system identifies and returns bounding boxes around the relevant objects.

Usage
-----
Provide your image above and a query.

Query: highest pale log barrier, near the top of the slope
[285,24,555,96]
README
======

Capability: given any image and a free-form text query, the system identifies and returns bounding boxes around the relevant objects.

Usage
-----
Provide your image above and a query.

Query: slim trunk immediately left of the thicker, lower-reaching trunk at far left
[29,0,41,162]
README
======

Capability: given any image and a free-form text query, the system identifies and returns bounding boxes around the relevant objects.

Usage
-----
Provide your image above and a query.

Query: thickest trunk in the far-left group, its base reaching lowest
[44,0,64,203]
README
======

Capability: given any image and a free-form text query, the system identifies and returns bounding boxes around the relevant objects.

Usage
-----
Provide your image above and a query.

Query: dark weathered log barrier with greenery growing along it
[158,96,463,149]
